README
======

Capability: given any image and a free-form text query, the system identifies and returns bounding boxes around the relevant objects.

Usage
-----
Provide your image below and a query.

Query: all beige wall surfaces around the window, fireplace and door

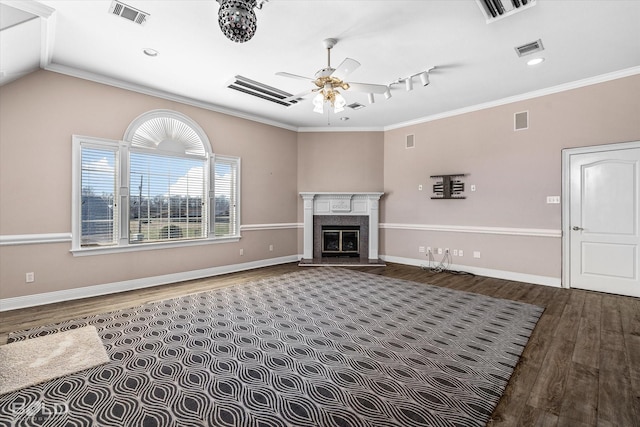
[0,71,640,299]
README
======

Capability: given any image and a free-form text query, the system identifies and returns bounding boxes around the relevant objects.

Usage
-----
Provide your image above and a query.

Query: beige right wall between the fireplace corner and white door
[381,76,640,279]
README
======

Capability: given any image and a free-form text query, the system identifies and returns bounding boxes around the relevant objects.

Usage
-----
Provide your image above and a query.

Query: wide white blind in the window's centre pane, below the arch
[129,152,207,243]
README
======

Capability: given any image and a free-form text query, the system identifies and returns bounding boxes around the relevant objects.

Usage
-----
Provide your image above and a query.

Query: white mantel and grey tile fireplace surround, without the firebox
[300,192,384,265]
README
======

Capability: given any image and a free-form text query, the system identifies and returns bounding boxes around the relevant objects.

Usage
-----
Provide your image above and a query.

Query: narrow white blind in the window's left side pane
[80,146,118,247]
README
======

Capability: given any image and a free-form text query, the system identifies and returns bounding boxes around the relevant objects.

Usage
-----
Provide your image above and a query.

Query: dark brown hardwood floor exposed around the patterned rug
[0,263,640,427]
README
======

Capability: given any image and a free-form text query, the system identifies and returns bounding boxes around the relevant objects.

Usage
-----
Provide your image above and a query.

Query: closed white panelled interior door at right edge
[565,148,640,297]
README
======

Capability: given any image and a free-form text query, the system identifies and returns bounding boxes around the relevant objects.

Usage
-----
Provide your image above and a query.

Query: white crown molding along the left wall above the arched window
[43,63,298,132]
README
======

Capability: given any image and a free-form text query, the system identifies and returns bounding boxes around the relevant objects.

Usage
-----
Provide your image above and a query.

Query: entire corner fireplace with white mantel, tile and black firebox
[300,193,383,265]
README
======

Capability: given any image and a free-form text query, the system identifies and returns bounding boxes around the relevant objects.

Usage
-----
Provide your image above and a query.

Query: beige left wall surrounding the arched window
[0,71,298,298]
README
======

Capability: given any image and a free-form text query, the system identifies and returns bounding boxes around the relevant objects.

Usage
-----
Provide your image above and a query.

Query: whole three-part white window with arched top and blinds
[72,110,240,253]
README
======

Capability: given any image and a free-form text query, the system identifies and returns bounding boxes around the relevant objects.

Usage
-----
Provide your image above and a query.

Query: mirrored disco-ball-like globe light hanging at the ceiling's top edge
[216,0,268,43]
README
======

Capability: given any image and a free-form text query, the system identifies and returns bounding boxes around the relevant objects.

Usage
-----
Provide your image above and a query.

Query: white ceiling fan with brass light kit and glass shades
[276,39,391,114]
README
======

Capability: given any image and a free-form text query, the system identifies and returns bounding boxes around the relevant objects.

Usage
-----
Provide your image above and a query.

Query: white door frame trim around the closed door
[561,141,640,288]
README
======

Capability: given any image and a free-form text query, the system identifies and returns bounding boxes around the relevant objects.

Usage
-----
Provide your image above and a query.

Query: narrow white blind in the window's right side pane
[213,155,240,237]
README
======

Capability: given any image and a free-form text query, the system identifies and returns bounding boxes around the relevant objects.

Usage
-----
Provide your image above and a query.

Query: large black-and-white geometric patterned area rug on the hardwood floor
[0,267,543,427]
